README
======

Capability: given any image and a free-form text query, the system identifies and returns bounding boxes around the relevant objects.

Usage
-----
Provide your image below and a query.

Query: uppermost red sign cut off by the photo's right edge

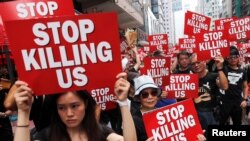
[225,16,250,41]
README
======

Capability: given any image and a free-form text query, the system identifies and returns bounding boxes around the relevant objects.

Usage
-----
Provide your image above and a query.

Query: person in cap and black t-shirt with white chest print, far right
[220,46,248,125]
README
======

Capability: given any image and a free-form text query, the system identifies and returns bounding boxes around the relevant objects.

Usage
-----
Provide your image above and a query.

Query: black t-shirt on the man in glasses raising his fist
[196,72,219,112]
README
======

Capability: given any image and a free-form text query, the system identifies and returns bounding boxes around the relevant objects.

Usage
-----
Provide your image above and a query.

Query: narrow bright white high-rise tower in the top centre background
[162,0,175,44]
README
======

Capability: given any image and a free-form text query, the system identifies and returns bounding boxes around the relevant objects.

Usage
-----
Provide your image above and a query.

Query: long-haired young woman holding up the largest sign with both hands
[14,73,136,141]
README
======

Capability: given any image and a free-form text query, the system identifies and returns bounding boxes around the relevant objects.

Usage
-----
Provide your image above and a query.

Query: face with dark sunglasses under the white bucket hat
[140,88,158,109]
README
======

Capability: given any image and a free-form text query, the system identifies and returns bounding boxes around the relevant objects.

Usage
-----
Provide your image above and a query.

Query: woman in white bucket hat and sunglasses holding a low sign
[131,75,205,141]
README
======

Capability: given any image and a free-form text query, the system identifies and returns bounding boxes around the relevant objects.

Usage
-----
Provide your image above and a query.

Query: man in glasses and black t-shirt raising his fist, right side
[191,54,228,130]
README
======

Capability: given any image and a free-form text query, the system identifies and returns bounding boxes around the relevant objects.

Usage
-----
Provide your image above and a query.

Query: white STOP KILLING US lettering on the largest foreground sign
[21,19,113,88]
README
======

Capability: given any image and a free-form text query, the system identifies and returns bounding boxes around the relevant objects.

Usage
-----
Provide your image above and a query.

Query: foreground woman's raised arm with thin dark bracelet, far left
[13,81,33,141]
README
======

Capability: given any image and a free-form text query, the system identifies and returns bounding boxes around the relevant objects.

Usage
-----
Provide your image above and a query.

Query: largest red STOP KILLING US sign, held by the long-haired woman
[5,13,122,100]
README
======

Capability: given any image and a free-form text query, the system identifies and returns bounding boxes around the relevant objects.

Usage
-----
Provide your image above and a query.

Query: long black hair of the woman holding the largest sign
[48,90,101,141]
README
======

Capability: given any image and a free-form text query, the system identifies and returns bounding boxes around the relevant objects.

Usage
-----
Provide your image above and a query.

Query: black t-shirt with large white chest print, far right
[221,67,247,102]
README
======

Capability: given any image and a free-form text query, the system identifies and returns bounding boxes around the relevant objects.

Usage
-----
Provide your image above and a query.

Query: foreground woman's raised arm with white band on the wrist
[114,73,137,141]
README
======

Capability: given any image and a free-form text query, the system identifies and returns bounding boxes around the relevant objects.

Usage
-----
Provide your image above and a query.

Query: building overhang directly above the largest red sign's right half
[73,0,143,29]
